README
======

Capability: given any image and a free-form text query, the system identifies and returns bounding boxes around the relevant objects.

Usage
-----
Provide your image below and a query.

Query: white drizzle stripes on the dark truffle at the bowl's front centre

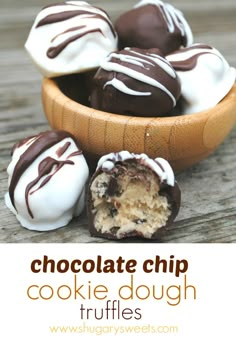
[101,48,177,103]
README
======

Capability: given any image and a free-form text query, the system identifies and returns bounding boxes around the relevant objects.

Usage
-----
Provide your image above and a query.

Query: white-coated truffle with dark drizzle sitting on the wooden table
[5,131,89,231]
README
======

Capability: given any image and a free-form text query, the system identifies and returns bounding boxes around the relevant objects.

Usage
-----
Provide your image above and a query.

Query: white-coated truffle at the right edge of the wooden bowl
[166,43,236,114]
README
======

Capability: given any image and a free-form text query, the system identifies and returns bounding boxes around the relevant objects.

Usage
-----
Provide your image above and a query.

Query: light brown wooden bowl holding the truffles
[42,75,236,171]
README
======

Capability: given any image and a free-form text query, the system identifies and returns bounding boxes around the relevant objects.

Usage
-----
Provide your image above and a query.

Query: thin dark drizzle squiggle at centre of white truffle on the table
[25,156,74,219]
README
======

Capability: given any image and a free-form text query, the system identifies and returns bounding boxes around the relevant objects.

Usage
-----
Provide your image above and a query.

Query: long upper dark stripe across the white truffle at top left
[36,9,116,37]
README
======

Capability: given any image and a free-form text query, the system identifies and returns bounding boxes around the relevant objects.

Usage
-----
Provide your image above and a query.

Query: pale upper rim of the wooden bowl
[42,77,236,126]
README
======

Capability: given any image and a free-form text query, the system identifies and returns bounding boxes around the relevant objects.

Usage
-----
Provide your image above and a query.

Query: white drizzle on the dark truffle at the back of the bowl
[134,0,193,46]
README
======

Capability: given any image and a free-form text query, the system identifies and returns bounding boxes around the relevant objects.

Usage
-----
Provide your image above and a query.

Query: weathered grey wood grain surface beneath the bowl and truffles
[0,0,236,243]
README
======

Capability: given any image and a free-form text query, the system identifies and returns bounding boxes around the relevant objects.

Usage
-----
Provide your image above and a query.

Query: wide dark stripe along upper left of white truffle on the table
[9,131,71,209]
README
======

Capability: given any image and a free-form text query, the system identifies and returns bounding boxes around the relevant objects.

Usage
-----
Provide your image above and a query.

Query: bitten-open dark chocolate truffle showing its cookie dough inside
[87,151,180,240]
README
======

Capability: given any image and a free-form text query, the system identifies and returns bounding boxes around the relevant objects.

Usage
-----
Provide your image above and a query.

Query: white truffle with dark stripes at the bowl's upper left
[25,1,117,77]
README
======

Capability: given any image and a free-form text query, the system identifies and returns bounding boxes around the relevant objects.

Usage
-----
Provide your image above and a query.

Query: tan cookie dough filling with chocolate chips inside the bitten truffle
[91,161,171,239]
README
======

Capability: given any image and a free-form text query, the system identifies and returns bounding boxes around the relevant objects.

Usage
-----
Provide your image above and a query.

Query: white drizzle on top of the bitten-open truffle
[97,151,175,186]
